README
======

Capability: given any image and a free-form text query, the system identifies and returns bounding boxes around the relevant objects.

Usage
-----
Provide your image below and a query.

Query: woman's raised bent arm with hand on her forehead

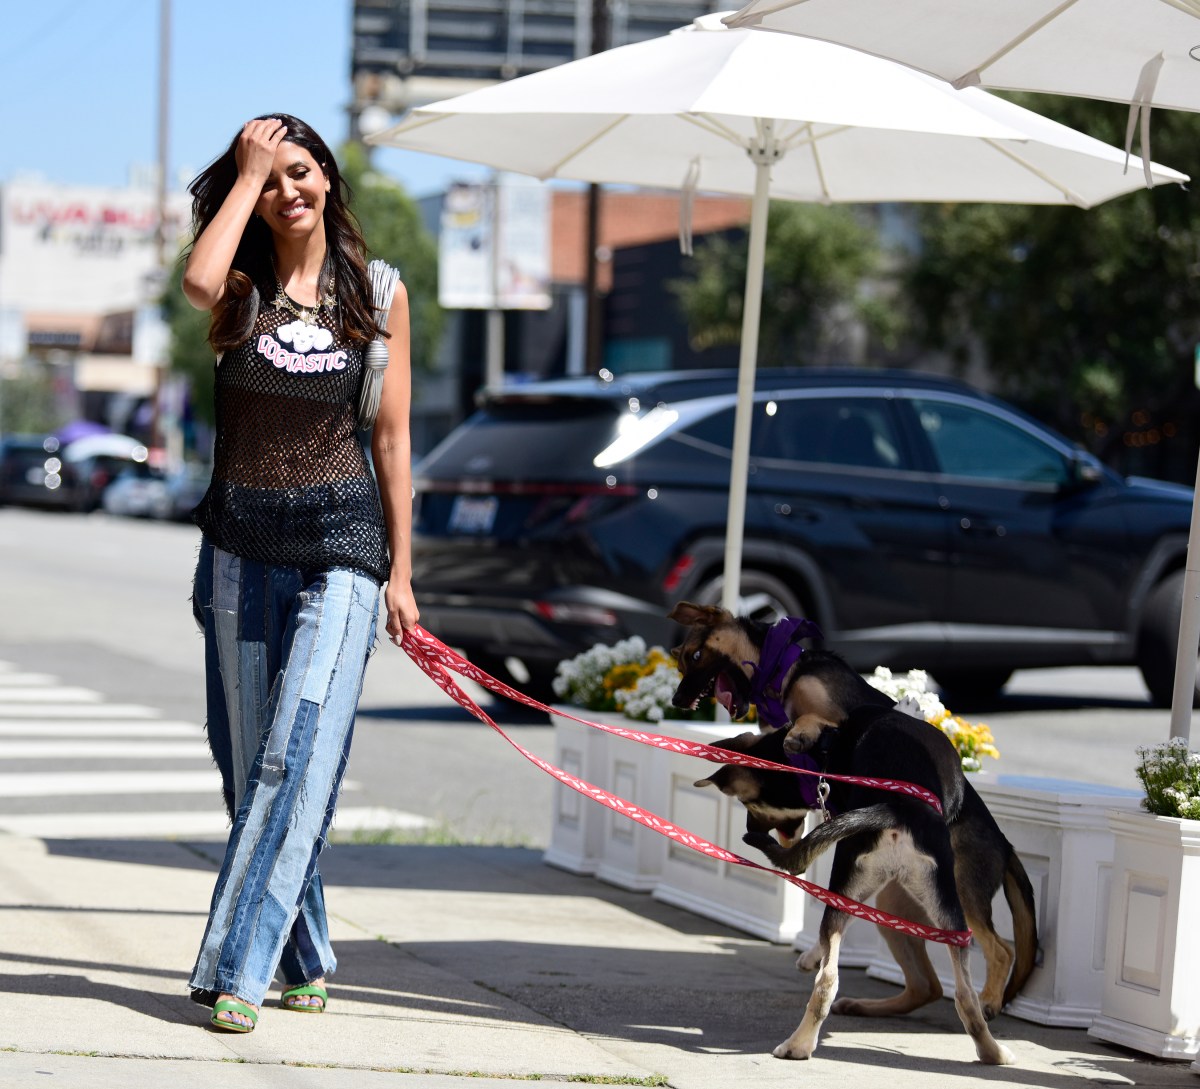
[184,118,287,311]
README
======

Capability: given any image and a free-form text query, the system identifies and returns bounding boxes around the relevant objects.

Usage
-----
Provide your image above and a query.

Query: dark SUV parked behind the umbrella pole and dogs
[414,368,1192,705]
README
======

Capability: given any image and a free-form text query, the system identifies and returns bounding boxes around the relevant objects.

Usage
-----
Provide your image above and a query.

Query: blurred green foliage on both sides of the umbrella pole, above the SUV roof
[670,201,900,366]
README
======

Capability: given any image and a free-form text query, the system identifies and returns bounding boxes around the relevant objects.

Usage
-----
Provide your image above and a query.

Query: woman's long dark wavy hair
[188,114,388,351]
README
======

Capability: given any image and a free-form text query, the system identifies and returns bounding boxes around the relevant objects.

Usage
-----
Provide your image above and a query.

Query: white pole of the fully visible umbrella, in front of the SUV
[721,121,779,614]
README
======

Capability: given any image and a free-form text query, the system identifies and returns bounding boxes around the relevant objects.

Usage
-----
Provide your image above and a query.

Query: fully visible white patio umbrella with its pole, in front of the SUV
[368,14,1187,628]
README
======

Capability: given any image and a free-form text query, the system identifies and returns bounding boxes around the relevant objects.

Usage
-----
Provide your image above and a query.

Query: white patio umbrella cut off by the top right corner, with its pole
[725,0,1200,738]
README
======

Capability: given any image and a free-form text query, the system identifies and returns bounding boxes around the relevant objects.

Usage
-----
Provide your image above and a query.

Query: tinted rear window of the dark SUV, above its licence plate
[419,399,618,480]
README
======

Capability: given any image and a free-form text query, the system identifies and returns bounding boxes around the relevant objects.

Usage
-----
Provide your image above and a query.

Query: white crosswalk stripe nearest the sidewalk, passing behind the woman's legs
[0,806,432,840]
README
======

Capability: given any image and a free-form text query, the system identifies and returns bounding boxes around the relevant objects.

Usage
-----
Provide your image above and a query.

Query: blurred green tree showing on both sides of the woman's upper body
[162,144,443,423]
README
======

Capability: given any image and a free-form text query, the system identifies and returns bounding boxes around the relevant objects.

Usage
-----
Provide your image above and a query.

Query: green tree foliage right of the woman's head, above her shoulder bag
[337,144,444,372]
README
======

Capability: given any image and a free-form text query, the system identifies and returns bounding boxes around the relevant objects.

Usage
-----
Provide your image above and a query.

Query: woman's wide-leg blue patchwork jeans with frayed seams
[190,540,379,1005]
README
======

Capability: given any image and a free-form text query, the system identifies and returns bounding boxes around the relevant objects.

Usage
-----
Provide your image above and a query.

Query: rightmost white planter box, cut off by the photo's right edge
[1088,812,1200,1060]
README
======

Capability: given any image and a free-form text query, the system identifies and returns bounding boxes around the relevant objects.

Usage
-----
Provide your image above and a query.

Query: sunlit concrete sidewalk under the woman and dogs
[0,836,1200,1089]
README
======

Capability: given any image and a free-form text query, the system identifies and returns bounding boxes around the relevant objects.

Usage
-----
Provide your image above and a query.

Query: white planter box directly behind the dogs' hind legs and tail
[868,774,1141,1028]
